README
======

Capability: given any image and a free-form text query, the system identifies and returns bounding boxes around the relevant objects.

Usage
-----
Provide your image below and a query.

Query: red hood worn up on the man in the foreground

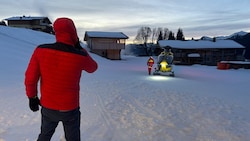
[53,18,78,46]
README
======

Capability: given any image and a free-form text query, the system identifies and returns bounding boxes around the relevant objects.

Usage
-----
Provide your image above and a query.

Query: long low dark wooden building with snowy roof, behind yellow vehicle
[158,40,245,65]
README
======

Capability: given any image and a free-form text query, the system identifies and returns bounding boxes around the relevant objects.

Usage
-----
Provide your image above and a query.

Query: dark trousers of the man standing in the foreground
[37,107,81,141]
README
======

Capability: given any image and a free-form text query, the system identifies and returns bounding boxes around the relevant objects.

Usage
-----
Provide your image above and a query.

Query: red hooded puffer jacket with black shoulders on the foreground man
[24,18,97,110]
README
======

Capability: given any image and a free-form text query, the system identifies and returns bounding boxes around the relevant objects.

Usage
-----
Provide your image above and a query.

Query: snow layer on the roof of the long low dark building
[158,40,245,49]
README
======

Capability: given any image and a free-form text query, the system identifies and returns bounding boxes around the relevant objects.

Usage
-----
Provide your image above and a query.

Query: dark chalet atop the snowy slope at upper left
[5,16,53,33]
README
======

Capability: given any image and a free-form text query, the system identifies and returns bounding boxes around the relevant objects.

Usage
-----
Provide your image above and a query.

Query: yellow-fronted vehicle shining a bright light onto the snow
[153,50,174,76]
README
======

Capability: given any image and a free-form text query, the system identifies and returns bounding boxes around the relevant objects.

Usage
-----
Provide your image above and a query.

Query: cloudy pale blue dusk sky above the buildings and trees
[0,0,250,40]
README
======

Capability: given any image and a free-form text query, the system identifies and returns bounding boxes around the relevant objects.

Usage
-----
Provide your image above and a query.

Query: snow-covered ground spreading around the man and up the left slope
[0,26,250,141]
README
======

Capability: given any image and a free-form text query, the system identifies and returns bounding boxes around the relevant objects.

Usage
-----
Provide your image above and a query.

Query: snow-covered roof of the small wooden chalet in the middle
[84,31,128,41]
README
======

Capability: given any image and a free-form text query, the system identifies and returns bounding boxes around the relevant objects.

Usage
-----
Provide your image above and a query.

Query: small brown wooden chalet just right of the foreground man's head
[84,31,128,60]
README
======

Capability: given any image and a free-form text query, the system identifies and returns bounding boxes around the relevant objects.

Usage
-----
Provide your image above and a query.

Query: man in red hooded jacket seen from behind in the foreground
[25,18,97,141]
